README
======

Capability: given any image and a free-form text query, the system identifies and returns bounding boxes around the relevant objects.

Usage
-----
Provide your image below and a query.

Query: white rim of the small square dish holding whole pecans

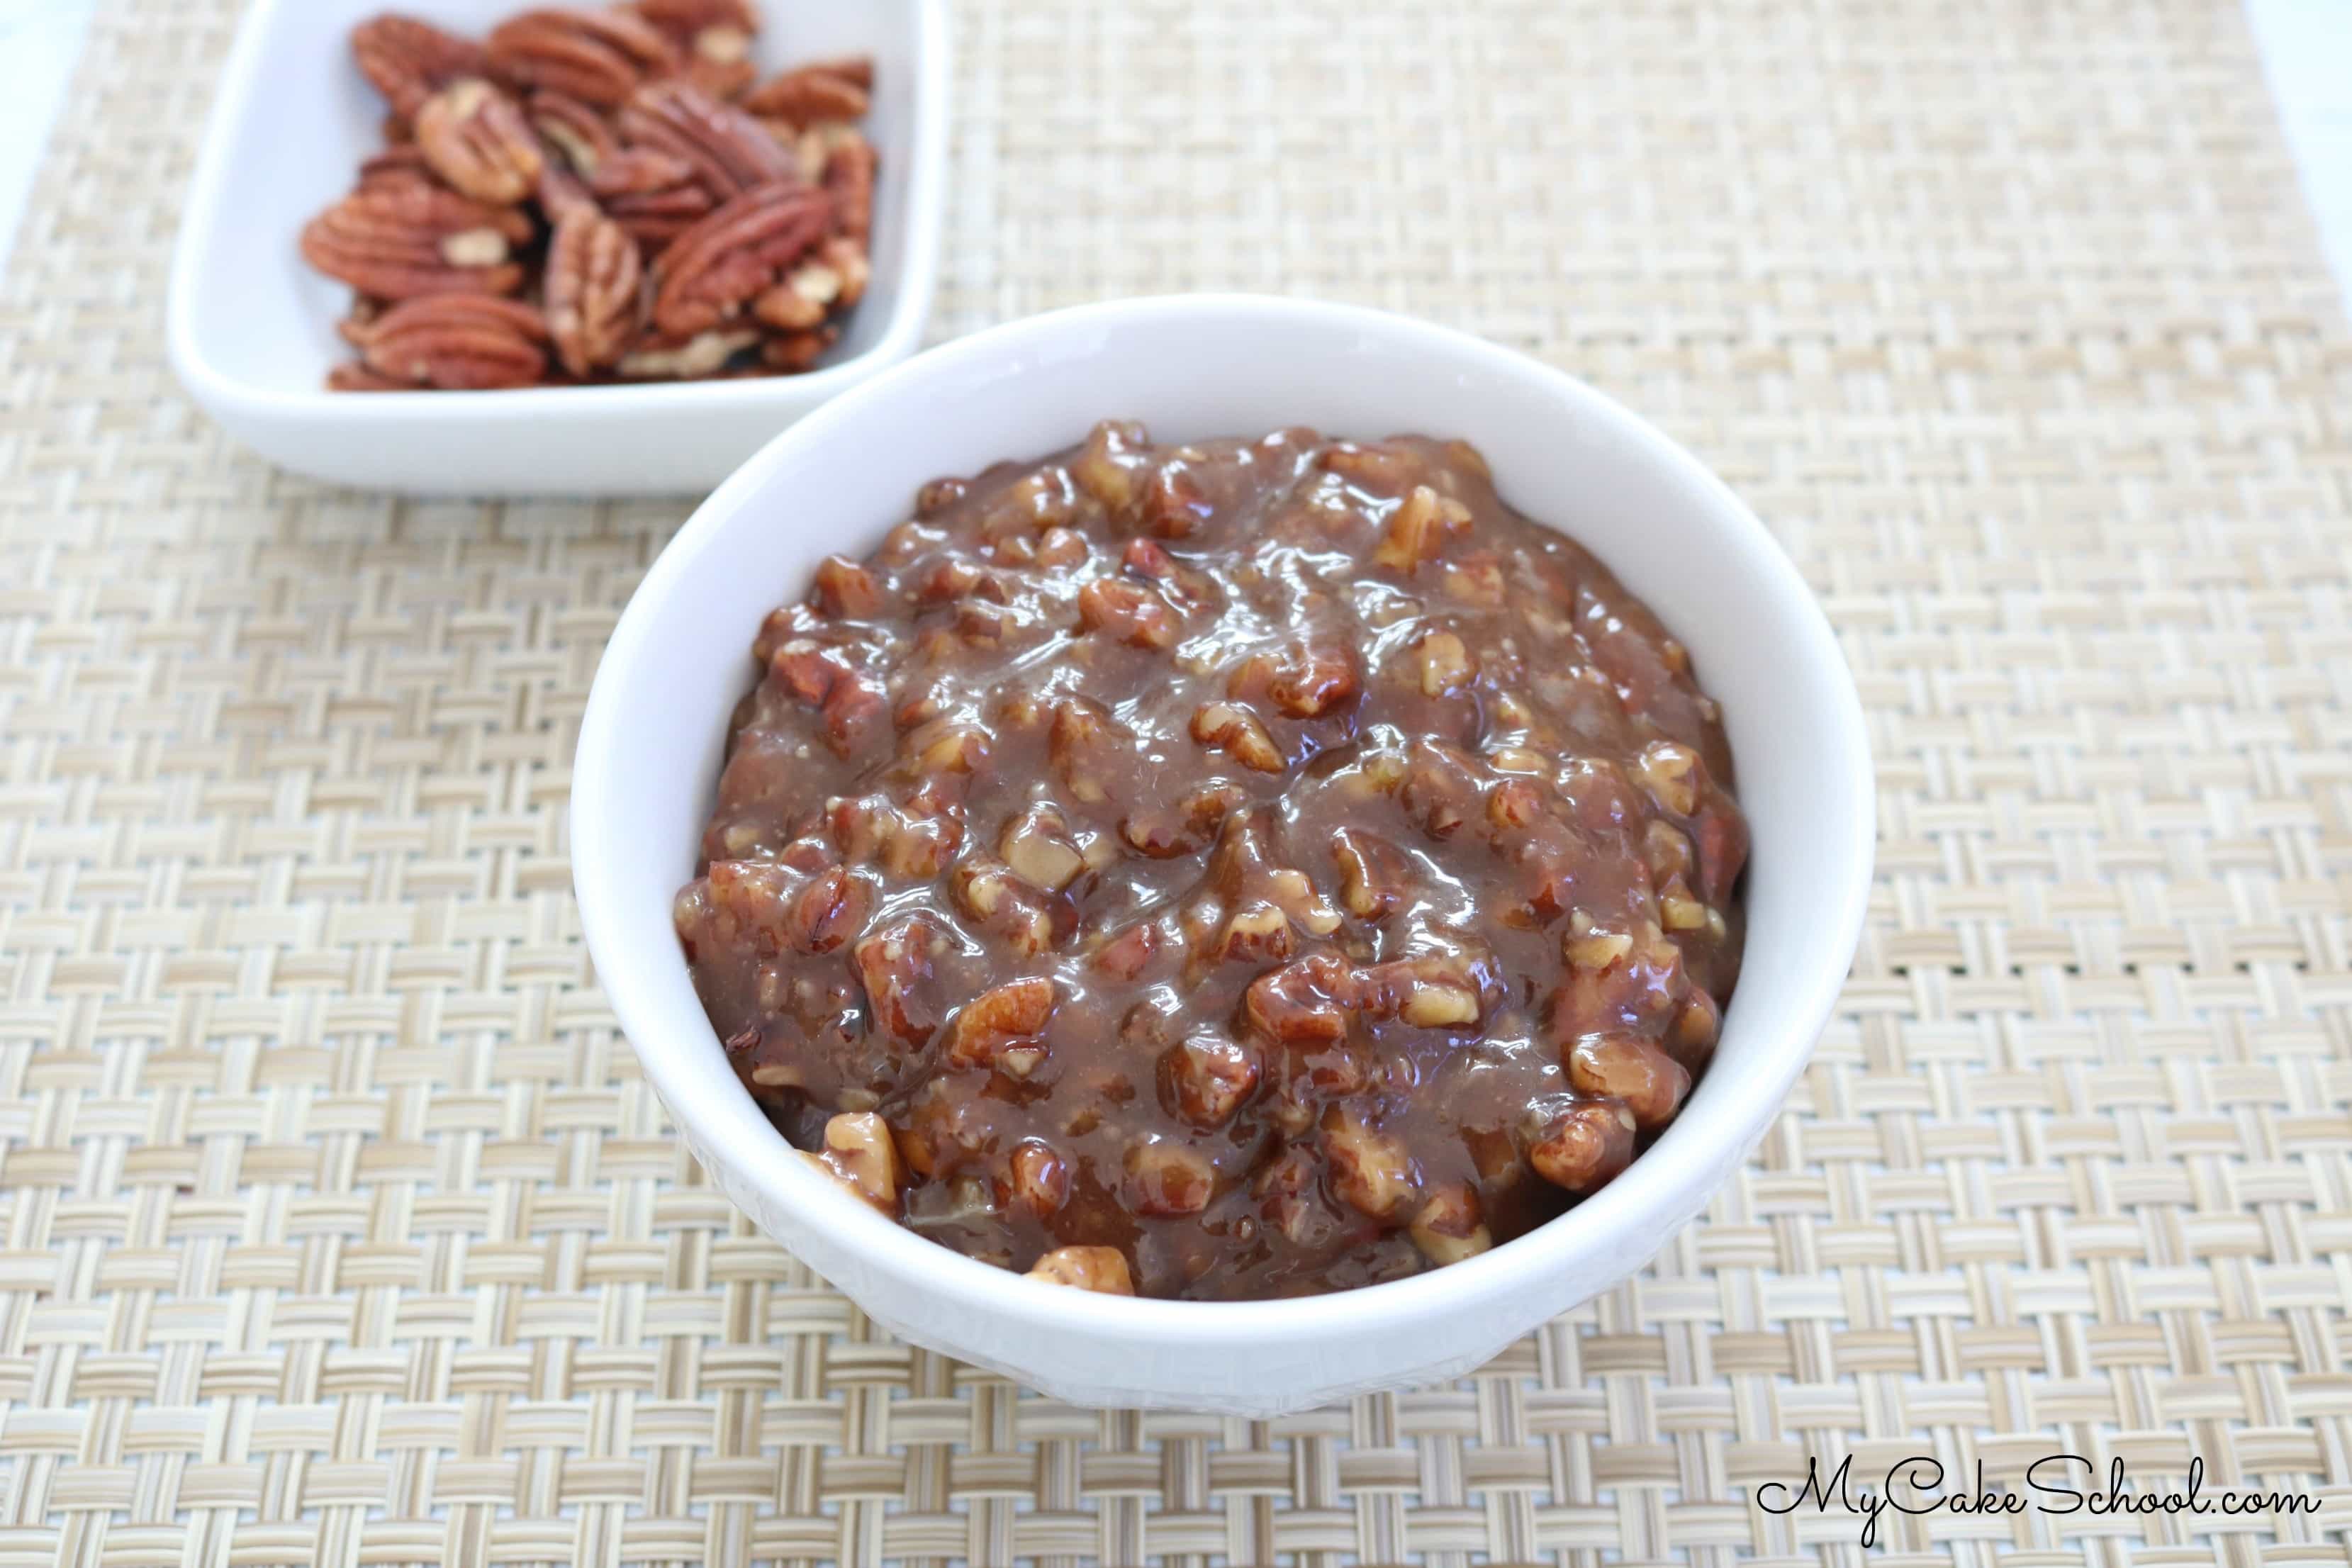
[164,0,955,428]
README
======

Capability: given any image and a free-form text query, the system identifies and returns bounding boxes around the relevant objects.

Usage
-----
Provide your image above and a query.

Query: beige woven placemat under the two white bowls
[0,0,2352,1568]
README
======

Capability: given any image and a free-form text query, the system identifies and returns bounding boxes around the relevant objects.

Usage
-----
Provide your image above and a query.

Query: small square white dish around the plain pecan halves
[167,0,948,493]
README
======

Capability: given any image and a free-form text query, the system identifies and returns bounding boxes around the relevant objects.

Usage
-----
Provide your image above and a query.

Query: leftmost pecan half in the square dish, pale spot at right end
[301,179,532,298]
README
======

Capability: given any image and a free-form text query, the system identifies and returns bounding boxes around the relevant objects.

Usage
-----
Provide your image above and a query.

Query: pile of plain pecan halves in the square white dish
[301,0,878,391]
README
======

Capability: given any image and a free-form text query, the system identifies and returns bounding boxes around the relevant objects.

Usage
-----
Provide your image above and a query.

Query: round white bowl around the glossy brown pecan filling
[571,296,1872,1415]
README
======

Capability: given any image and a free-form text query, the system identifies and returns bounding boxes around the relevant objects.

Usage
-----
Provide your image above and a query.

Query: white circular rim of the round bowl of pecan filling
[569,294,1877,1350]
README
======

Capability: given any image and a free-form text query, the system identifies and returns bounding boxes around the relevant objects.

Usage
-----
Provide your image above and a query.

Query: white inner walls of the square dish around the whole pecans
[188,0,922,395]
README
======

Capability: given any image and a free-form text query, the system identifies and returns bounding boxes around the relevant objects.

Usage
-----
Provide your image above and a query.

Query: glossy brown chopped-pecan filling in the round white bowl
[678,423,1747,1300]
